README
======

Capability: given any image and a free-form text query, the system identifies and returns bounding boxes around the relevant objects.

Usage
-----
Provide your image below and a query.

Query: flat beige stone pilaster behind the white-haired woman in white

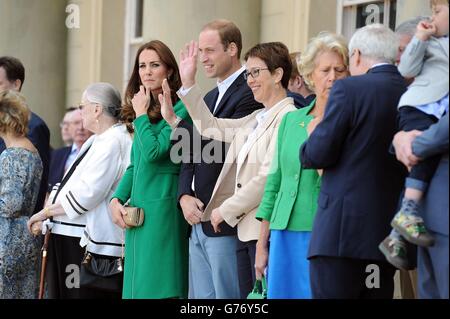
[66,0,125,105]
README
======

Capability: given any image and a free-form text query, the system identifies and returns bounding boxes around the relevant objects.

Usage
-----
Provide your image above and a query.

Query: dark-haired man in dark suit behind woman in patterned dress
[0,56,50,214]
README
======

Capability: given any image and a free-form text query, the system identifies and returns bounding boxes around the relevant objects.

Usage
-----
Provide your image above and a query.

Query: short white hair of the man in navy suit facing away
[349,24,399,64]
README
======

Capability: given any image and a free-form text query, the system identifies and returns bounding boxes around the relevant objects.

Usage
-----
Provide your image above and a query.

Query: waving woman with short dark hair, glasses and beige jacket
[160,42,296,298]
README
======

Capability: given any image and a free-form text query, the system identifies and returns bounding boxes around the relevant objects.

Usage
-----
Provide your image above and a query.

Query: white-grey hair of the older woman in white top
[83,82,122,119]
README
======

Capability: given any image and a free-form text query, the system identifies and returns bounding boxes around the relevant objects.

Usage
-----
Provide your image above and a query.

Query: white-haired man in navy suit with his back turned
[300,24,406,298]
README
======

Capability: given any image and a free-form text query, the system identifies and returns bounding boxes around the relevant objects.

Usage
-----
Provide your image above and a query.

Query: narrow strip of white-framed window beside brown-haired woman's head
[123,0,144,88]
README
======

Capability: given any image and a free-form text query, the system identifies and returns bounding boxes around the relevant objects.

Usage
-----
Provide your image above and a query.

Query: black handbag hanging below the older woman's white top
[80,252,123,293]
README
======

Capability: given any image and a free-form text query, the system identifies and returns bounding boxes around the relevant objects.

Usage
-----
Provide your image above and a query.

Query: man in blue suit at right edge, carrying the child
[393,113,449,299]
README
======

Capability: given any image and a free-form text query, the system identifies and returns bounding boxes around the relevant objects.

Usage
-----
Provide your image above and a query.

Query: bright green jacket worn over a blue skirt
[256,101,320,231]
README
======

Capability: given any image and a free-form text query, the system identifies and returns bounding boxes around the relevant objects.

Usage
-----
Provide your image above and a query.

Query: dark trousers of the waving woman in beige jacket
[236,240,256,299]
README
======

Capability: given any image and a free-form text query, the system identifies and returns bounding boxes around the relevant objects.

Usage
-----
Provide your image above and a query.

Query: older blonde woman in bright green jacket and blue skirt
[255,32,348,299]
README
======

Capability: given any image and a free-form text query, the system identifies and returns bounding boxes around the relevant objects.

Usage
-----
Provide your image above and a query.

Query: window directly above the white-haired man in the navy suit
[337,0,397,39]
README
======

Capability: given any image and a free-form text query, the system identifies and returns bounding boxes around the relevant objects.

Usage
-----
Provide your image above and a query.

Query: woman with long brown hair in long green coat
[110,41,189,299]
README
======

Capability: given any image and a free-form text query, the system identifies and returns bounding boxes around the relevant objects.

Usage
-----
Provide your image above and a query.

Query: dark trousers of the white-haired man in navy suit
[309,256,395,299]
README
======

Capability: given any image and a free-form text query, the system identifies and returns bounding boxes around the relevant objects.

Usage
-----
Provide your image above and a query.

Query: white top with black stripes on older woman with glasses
[50,124,132,256]
